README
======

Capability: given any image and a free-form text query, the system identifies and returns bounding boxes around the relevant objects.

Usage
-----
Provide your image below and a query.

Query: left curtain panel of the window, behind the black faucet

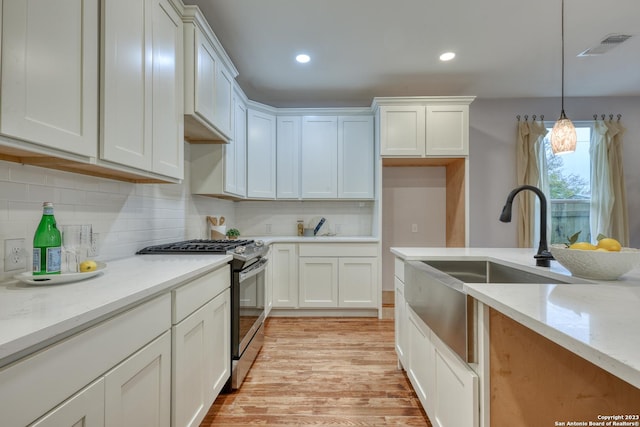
[516,120,551,248]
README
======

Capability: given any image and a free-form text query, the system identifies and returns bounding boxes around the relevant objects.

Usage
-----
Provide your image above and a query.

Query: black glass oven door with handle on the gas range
[231,258,268,360]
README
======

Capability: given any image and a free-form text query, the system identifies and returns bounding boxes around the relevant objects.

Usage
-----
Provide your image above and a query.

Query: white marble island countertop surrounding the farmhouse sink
[391,248,640,388]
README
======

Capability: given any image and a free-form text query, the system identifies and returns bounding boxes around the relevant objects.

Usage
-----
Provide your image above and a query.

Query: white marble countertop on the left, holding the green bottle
[0,255,231,366]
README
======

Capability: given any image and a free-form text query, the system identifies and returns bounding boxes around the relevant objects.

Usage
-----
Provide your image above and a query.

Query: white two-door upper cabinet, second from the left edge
[100,0,184,179]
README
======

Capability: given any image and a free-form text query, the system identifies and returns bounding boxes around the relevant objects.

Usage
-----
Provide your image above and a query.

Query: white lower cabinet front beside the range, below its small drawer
[171,289,231,426]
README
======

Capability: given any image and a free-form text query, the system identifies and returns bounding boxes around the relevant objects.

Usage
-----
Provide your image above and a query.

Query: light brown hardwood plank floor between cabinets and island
[201,317,431,427]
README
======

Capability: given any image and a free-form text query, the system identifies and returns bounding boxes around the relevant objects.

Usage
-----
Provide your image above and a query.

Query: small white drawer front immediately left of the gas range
[172,264,231,325]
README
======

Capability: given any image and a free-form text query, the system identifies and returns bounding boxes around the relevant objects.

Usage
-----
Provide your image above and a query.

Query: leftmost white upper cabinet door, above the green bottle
[0,0,99,157]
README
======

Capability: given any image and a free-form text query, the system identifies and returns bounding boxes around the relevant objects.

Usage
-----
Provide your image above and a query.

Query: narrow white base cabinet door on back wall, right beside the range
[269,243,298,308]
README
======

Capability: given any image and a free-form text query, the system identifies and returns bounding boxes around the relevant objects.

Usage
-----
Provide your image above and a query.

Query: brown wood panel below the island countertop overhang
[490,309,640,427]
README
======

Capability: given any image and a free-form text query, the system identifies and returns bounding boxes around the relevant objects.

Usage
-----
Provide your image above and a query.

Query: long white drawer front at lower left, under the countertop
[0,294,171,426]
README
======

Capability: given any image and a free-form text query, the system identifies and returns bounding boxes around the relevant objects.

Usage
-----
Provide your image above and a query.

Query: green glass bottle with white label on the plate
[33,202,62,275]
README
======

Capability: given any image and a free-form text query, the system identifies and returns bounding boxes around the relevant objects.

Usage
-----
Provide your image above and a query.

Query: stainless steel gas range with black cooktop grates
[137,240,268,390]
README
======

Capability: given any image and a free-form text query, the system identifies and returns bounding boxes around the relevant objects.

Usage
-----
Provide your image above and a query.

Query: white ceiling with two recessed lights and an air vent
[185,0,640,107]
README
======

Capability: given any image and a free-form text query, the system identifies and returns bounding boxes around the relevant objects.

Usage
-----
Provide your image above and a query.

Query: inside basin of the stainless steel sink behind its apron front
[422,261,572,284]
